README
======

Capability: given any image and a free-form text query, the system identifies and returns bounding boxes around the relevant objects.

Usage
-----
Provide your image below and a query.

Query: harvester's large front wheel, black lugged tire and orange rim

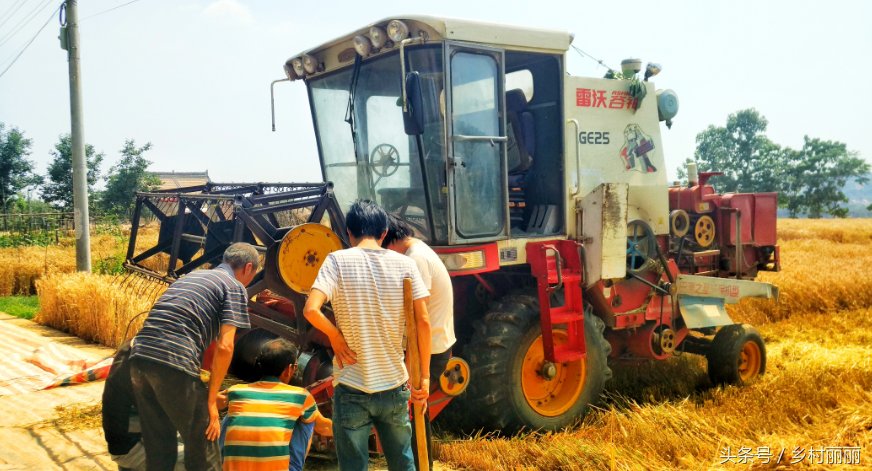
[466,294,611,431]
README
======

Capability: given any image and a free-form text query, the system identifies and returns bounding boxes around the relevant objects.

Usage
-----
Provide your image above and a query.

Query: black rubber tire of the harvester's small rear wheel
[706,324,766,385]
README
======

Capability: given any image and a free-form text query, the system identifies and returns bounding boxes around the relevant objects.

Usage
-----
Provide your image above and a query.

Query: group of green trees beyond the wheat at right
[678,108,872,218]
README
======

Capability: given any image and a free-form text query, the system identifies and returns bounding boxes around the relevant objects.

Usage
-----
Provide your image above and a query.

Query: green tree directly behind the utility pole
[42,134,104,211]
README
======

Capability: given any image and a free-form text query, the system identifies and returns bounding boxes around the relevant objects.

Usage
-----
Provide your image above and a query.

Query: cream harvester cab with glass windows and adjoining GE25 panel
[285,18,678,276]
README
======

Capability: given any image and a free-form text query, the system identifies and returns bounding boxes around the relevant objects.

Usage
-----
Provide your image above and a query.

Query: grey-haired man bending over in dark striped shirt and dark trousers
[130,243,259,470]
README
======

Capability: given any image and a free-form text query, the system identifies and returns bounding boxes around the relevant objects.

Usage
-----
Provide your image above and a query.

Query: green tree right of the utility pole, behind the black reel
[100,139,160,217]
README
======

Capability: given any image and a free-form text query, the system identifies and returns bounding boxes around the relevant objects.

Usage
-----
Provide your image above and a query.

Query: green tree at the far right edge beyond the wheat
[779,136,869,218]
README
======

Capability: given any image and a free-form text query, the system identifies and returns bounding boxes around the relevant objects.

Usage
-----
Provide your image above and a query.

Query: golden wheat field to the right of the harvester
[436,219,872,471]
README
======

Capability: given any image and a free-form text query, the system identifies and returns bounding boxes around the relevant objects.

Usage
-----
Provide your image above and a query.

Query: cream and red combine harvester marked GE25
[126,17,779,431]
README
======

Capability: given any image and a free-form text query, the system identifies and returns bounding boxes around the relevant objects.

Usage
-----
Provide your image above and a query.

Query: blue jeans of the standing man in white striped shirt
[333,384,415,471]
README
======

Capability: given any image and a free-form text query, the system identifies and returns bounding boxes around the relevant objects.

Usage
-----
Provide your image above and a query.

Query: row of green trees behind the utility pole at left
[0,122,160,218]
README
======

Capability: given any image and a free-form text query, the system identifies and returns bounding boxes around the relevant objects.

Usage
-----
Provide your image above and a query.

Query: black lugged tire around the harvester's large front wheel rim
[465,294,612,433]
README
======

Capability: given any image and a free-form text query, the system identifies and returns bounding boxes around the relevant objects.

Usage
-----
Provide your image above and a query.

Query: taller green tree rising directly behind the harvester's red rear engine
[678,109,785,193]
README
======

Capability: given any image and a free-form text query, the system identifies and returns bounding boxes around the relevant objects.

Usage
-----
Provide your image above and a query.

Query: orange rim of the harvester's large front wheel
[521,331,586,417]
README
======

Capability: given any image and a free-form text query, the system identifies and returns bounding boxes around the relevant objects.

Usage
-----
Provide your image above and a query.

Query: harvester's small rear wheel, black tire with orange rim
[706,324,766,384]
